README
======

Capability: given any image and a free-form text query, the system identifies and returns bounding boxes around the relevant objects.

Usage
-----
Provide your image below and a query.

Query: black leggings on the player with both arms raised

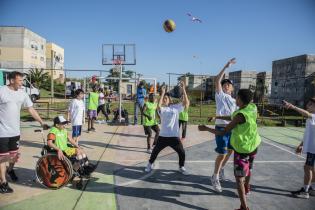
[149,136,185,167]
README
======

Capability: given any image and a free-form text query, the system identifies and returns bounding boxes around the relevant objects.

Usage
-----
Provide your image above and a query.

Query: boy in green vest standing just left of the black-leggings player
[142,93,160,154]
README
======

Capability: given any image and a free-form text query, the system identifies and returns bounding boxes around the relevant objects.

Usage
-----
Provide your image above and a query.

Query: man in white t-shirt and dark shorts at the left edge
[0,71,48,193]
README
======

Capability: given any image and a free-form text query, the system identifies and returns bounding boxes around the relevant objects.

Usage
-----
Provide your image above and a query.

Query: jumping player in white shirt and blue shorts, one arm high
[211,58,236,192]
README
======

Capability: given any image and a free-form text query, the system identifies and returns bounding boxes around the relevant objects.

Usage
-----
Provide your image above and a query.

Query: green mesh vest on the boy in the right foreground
[231,103,261,154]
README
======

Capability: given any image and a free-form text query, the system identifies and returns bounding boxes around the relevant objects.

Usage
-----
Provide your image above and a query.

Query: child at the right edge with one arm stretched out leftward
[283,97,315,199]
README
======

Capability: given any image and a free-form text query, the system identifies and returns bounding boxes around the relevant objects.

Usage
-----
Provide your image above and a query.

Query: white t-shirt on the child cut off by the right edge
[303,114,315,154]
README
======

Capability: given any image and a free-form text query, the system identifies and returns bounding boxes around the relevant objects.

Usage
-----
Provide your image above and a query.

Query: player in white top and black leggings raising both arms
[145,82,189,175]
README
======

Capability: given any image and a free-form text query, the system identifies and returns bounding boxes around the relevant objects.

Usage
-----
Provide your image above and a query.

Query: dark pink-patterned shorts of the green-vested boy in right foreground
[234,149,257,177]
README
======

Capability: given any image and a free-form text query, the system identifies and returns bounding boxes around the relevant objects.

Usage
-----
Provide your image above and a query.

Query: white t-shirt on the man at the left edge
[0,86,33,138]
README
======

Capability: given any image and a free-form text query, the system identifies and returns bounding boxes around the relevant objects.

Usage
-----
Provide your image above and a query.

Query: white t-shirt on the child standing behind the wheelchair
[68,98,85,126]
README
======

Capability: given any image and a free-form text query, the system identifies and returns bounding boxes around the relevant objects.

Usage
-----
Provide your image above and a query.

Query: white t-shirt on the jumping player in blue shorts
[215,91,237,125]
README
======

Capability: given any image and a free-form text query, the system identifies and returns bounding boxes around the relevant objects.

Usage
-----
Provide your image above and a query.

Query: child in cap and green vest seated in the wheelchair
[47,116,96,175]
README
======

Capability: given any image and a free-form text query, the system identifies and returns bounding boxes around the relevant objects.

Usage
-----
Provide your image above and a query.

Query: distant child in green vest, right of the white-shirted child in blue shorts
[87,86,99,132]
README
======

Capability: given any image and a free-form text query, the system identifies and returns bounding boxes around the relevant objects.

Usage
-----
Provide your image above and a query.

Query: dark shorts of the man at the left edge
[0,136,20,156]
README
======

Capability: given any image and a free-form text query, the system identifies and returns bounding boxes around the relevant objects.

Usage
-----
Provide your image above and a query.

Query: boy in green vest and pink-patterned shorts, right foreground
[198,89,261,210]
